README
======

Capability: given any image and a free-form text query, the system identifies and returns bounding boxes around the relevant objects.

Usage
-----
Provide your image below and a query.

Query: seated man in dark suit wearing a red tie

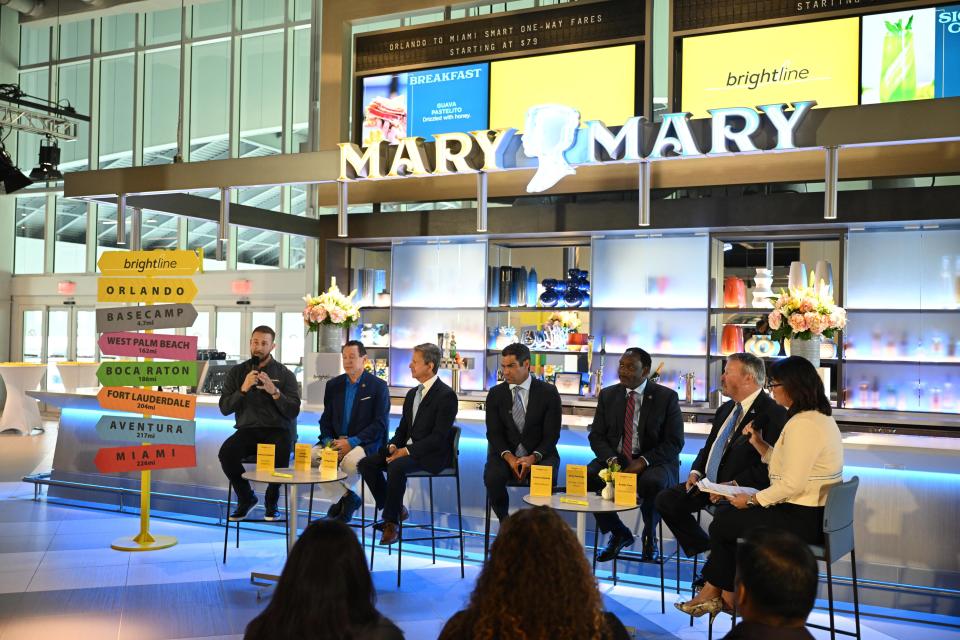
[587,347,683,562]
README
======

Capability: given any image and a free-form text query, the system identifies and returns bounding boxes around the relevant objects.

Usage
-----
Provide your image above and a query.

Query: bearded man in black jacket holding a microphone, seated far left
[219,326,300,521]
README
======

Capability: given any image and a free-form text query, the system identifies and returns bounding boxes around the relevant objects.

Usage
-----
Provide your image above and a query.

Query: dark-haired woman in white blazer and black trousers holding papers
[675,356,843,618]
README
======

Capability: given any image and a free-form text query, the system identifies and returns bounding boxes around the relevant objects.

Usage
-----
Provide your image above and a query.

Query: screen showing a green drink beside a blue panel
[860,4,960,104]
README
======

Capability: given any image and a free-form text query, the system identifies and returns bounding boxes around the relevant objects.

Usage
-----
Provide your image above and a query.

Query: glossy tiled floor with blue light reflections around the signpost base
[0,424,960,640]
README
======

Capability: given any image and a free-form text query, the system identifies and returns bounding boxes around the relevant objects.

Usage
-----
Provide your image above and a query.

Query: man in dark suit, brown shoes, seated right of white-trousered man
[359,343,458,545]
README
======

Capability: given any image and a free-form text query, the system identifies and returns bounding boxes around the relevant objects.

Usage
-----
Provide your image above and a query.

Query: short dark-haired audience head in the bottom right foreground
[735,527,818,627]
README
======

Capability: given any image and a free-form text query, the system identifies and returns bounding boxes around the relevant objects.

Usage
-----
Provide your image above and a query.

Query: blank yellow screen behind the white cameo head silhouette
[490,44,637,131]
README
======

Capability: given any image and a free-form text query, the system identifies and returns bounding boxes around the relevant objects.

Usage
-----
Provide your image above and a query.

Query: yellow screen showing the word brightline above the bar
[680,18,860,118]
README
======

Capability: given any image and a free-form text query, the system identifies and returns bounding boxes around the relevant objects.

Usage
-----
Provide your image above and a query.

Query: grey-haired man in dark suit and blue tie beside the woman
[656,353,787,556]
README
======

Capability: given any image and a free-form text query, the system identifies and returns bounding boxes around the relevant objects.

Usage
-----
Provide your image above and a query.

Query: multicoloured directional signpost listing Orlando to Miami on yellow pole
[94,251,203,551]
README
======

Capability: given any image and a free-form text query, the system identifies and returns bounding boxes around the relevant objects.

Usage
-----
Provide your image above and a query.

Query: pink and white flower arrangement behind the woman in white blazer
[767,282,847,340]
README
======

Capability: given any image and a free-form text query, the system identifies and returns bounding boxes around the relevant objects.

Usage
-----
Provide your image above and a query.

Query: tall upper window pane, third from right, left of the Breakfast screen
[190,41,230,162]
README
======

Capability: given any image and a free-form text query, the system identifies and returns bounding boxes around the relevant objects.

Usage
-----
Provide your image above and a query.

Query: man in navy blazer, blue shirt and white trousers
[313,340,390,522]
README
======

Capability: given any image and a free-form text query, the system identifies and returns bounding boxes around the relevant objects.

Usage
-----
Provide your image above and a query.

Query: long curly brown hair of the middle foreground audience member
[439,507,606,640]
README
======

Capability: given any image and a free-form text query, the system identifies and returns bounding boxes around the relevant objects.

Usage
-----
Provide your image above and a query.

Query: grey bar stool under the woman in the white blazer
[807,476,860,640]
